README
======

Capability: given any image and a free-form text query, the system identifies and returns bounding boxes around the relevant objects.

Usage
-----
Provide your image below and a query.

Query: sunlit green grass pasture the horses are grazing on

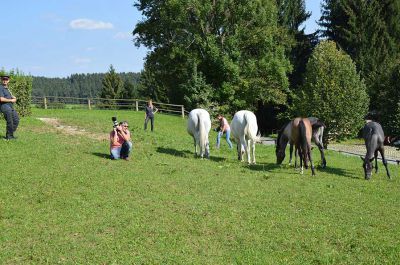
[0,109,400,264]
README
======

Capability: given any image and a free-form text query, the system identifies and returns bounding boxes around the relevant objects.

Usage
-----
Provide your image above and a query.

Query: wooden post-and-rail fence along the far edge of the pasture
[32,96,188,118]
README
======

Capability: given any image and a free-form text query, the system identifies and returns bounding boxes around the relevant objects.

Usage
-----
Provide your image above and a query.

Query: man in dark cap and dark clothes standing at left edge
[0,75,19,140]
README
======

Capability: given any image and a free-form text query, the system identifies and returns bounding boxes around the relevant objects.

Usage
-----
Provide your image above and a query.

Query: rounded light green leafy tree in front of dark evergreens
[294,41,369,144]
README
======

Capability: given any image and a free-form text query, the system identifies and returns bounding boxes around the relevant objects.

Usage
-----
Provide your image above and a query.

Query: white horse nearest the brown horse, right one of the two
[231,110,258,164]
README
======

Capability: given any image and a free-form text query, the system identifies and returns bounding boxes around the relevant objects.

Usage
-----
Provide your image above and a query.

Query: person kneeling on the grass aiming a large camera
[110,121,132,160]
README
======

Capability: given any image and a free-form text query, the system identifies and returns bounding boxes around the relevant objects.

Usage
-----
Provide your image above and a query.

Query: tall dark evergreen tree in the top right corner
[320,0,400,112]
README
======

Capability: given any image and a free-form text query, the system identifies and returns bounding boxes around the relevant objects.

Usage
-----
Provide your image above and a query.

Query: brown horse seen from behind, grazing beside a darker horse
[275,118,315,175]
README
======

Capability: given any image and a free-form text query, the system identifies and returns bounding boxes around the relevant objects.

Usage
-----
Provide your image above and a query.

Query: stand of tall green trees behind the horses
[133,0,400,138]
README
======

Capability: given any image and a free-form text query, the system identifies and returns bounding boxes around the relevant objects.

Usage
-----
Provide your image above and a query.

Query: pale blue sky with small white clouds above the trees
[0,0,320,77]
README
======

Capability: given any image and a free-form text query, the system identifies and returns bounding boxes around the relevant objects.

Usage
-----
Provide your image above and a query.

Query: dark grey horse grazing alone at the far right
[361,122,390,180]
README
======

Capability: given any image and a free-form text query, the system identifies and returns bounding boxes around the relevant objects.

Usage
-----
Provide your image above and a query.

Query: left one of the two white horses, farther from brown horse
[187,109,211,158]
